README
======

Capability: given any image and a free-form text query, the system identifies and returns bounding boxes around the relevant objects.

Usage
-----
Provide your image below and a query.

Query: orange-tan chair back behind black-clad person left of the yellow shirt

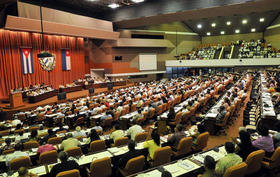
[125,155,145,176]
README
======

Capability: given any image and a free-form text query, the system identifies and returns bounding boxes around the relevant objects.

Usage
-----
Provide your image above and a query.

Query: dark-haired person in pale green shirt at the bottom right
[215,142,242,176]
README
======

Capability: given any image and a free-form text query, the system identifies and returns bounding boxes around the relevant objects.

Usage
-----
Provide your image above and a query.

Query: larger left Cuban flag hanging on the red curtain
[20,48,33,74]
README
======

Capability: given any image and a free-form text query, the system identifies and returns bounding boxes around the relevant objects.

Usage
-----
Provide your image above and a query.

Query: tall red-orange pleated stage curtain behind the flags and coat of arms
[0,30,85,99]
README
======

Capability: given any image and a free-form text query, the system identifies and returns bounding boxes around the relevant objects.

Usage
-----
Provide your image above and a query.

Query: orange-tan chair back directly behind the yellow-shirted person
[152,146,172,167]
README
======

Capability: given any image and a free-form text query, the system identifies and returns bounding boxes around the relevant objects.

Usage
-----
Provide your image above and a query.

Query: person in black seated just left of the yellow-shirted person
[118,140,141,169]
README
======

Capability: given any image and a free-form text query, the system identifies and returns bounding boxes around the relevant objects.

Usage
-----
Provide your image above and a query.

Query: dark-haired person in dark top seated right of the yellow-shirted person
[167,124,186,148]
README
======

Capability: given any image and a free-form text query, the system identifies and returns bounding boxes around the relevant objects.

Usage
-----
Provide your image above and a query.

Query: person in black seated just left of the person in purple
[236,130,256,161]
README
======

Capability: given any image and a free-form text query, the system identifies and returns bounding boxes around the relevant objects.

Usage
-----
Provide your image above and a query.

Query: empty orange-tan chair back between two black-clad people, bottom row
[90,157,112,177]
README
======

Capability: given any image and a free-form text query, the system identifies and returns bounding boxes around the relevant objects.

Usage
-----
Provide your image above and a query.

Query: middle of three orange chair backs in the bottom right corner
[245,150,265,174]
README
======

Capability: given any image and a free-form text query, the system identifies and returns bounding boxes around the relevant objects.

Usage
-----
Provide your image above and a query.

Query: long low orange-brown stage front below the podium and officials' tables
[0,83,134,119]
